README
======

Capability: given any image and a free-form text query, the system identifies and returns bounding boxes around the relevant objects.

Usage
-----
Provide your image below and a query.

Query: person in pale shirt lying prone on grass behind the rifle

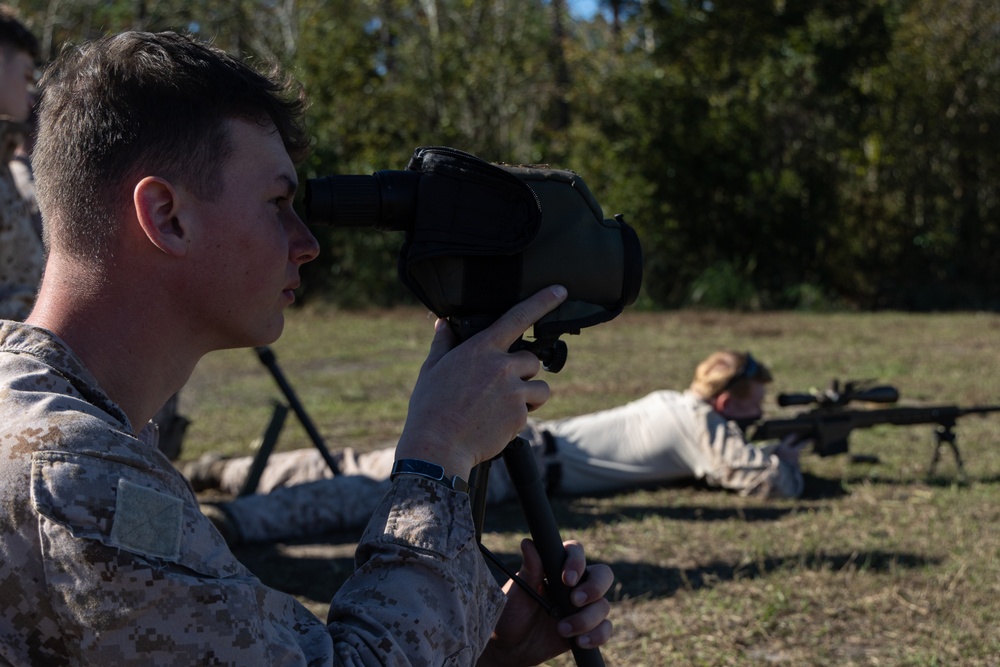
[188,351,806,543]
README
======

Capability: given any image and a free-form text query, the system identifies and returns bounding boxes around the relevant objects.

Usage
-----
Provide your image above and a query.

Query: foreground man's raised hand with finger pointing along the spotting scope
[396,285,566,479]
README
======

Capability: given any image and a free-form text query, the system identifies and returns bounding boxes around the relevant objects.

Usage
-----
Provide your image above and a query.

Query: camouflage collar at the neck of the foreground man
[0,320,132,432]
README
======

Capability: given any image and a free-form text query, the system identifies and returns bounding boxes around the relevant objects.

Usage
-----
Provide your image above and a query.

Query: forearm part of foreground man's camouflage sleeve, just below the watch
[328,477,504,665]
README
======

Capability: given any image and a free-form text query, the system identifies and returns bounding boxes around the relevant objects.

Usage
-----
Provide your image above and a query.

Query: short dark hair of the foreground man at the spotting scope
[33,32,308,258]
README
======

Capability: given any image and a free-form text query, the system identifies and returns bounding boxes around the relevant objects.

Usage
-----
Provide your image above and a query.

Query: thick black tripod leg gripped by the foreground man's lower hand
[503,438,604,667]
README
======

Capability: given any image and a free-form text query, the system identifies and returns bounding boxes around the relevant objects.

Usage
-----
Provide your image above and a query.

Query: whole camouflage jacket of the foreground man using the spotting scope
[0,322,503,667]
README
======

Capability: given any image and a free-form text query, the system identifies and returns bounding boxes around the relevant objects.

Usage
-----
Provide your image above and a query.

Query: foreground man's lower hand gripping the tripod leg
[478,540,615,667]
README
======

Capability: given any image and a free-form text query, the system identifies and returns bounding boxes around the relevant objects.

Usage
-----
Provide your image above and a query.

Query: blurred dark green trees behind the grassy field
[14,0,1000,310]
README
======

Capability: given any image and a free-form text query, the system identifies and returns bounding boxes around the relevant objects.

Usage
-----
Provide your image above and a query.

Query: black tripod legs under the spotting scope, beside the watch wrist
[469,437,604,667]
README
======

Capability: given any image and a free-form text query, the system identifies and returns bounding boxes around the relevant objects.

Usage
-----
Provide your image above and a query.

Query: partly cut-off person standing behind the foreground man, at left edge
[0,5,45,320]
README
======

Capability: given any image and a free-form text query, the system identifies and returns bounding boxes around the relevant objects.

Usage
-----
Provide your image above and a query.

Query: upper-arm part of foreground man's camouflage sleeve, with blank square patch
[21,452,333,666]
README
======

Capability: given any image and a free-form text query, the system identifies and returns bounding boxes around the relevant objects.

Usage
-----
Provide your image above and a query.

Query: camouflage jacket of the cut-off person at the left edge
[0,120,45,320]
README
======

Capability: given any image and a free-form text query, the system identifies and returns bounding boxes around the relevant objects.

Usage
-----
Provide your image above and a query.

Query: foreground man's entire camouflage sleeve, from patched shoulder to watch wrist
[22,452,503,666]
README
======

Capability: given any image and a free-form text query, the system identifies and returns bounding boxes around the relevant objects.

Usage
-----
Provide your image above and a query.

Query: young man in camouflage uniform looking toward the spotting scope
[0,33,613,667]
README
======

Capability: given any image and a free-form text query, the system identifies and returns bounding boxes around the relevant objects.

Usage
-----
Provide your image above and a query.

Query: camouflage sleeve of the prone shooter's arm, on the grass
[705,416,803,498]
